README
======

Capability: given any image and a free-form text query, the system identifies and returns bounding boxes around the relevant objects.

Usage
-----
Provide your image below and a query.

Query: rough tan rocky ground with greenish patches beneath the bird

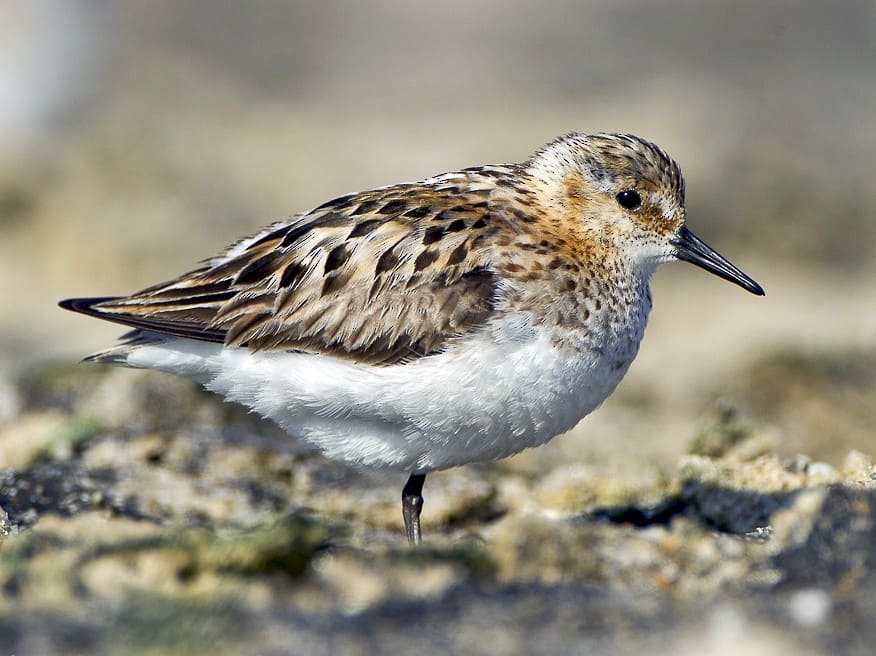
[0,363,876,654]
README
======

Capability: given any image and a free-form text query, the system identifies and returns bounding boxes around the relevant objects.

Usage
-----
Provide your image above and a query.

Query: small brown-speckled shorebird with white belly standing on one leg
[61,134,764,543]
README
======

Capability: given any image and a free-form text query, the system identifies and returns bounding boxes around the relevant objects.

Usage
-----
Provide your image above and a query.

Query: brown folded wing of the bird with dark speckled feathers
[90,171,510,364]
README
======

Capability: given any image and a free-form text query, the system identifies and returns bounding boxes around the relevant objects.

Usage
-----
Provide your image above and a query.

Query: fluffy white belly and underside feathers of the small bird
[121,312,644,473]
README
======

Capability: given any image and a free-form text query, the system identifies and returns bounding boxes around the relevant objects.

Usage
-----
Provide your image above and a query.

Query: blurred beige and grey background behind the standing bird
[0,0,876,472]
